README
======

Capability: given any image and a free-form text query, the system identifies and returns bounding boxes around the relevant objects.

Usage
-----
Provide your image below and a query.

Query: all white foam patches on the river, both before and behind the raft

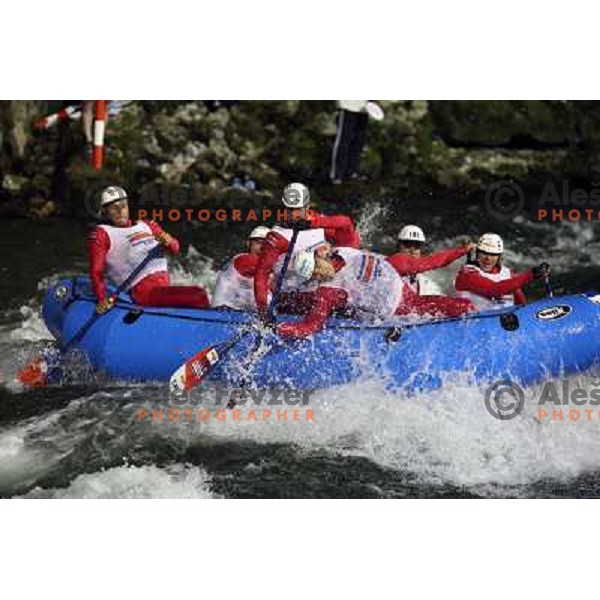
[0,210,600,498]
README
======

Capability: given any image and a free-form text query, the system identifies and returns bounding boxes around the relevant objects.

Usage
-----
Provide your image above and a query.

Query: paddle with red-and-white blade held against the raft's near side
[169,227,299,392]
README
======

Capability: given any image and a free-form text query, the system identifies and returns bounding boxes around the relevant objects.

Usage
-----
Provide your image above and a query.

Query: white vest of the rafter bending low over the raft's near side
[321,248,402,319]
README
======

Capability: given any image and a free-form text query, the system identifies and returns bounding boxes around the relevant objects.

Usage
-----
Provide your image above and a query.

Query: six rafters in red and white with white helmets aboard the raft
[88,183,550,338]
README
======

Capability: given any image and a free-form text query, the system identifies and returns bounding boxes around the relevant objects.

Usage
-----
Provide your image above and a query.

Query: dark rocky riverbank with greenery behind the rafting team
[0,101,600,218]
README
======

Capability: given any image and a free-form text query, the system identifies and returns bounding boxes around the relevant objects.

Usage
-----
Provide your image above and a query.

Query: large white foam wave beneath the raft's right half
[179,379,600,495]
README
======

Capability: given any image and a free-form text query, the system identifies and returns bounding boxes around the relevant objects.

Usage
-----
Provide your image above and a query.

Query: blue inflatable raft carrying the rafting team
[43,277,600,390]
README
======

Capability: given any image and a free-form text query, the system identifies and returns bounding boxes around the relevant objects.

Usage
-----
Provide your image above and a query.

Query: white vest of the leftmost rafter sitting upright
[98,221,168,290]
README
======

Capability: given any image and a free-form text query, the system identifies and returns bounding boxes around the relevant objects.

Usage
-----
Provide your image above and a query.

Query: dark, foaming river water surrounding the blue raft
[0,199,600,498]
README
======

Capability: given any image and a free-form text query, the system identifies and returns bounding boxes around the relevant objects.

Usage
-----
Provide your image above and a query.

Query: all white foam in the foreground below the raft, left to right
[0,370,600,498]
